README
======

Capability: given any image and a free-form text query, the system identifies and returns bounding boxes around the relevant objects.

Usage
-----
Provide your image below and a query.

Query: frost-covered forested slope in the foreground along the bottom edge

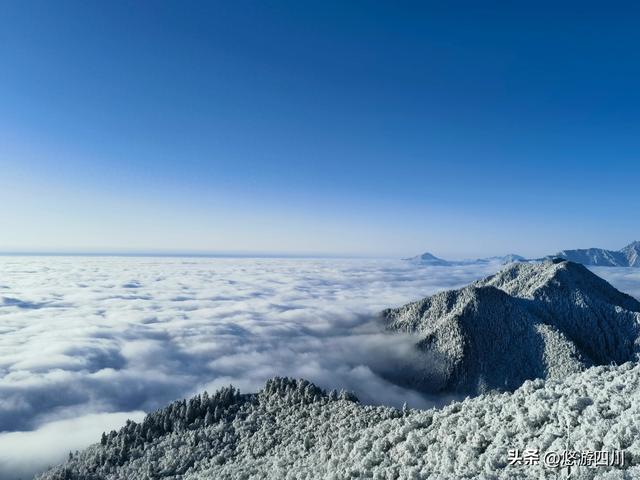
[38,363,640,480]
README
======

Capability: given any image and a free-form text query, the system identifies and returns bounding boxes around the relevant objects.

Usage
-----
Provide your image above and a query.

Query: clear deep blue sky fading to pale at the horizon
[0,0,640,257]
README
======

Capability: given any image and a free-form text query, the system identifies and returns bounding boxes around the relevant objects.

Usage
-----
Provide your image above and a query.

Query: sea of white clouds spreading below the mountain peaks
[0,257,640,480]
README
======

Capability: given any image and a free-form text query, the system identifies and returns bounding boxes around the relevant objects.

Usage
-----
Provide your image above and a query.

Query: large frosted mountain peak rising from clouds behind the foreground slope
[382,260,640,393]
